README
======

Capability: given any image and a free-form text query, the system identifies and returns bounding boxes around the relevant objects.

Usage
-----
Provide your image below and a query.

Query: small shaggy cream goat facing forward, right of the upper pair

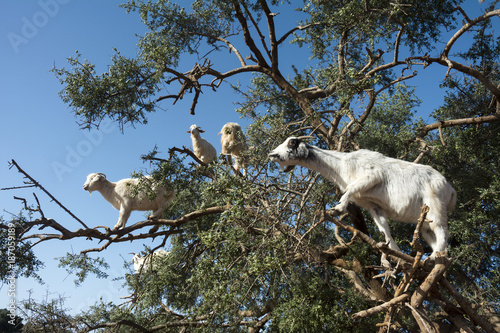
[219,122,248,175]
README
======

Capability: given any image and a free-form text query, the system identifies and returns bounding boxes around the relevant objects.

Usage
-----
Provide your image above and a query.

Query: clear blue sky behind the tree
[0,0,492,312]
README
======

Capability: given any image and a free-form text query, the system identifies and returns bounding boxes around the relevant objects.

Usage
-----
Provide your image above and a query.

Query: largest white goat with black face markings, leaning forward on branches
[269,137,456,257]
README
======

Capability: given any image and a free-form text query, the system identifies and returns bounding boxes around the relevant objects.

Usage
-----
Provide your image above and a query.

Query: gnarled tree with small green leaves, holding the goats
[1,0,500,332]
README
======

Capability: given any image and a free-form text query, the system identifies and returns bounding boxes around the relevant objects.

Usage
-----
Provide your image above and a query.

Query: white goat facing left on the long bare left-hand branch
[83,173,175,229]
